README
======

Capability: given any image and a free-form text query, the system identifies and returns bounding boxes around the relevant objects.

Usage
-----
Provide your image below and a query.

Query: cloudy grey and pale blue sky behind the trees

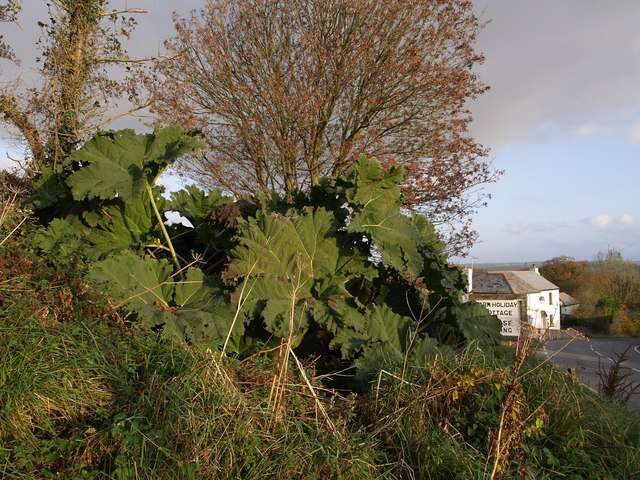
[0,0,640,262]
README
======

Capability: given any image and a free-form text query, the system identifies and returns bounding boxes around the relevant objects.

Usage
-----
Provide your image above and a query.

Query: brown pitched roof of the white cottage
[472,270,558,295]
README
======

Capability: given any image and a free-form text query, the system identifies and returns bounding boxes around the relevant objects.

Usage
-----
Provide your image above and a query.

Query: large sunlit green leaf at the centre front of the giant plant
[227,208,364,344]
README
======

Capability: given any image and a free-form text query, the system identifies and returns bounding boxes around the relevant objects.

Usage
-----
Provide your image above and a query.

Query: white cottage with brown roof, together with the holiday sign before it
[467,268,560,336]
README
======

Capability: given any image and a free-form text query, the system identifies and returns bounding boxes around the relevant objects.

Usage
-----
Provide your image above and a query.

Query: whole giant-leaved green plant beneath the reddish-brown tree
[32,127,499,379]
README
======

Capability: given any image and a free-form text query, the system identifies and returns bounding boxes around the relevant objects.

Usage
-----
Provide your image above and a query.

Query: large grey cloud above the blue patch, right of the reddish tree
[470,0,640,149]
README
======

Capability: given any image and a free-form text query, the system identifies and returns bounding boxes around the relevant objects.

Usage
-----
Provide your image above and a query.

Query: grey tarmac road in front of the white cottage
[542,337,640,409]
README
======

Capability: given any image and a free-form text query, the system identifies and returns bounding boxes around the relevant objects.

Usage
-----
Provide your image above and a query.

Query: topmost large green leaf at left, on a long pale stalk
[67,127,202,201]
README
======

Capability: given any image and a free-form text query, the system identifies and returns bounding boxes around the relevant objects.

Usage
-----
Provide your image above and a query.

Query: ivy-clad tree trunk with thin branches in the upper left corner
[0,0,142,171]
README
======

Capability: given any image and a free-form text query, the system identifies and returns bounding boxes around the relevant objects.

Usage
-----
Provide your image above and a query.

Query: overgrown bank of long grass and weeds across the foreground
[0,198,640,480]
